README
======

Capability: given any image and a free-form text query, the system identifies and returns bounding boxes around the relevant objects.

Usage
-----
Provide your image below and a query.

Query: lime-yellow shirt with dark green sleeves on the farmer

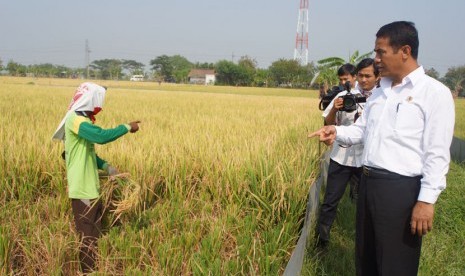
[65,113,131,199]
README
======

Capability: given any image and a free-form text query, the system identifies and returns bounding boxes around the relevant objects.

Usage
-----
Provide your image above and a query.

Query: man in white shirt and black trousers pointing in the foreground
[309,21,455,275]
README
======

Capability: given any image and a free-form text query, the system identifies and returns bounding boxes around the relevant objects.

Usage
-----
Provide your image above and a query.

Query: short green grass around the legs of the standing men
[302,163,465,276]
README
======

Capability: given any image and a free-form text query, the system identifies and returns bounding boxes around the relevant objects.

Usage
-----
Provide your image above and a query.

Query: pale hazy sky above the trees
[0,0,465,76]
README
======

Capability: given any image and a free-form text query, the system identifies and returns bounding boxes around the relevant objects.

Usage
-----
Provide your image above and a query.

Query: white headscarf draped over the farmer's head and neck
[52,82,106,140]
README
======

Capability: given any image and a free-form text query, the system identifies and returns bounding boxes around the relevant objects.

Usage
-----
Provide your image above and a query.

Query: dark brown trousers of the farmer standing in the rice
[71,199,102,274]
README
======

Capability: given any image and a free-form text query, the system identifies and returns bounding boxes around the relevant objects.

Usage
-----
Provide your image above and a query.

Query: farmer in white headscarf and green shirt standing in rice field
[53,82,140,274]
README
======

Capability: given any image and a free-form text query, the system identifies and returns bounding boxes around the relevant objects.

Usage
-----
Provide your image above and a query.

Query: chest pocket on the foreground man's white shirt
[394,100,424,136]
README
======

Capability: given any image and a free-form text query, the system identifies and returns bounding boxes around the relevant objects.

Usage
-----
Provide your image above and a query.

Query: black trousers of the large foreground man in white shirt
[355,167,421,276]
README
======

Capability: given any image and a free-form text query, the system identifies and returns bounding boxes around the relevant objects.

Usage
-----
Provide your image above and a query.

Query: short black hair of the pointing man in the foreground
[376,21,420,60]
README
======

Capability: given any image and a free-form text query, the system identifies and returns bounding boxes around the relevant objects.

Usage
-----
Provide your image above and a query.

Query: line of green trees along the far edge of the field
[0,55,465,96]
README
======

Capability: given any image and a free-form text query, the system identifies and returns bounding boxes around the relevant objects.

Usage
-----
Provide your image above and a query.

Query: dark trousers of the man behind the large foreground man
[316,159,362,241]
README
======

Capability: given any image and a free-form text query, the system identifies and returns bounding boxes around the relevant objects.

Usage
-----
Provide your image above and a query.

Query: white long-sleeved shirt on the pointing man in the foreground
[336,67,455,203]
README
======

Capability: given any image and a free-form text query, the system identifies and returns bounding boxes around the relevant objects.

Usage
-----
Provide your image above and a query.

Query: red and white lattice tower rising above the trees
[294,0,308,65]
